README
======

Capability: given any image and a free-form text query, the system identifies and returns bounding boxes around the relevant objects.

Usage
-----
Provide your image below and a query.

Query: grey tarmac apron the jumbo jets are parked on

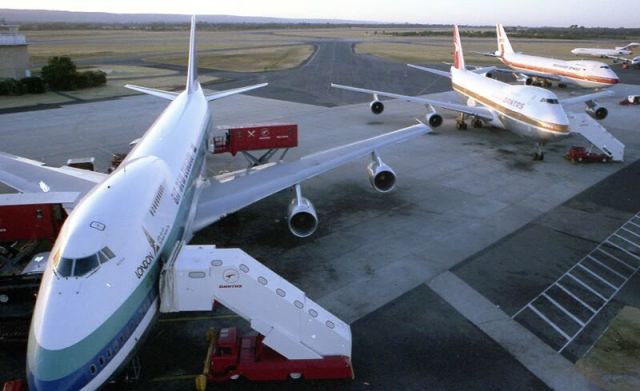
[0,39,640,390]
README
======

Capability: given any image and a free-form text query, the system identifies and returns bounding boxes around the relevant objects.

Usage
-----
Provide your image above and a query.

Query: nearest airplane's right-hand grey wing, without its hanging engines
[193,124,431,232]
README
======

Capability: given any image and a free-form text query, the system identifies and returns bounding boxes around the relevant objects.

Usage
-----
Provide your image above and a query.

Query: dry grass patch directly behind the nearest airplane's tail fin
[145,45,314,72]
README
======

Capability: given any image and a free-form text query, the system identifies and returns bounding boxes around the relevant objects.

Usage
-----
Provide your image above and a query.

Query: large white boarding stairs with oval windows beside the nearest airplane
[160,245,351,360]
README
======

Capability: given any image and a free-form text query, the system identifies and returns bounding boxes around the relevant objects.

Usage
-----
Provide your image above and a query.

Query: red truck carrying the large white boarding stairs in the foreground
[196,327,353,390]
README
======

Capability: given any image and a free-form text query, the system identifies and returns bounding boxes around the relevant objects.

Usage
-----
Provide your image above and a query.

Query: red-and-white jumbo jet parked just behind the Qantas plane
[483,24,619,88]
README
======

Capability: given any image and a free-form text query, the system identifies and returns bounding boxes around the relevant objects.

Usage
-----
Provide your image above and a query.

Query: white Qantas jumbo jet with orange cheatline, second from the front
[331,25,611,160]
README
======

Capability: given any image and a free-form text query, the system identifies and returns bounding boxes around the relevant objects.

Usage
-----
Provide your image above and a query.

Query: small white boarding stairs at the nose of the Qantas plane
[567,113,624,162]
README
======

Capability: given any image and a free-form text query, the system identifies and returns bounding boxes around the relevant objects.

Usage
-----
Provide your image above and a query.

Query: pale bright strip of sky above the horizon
[5,0,640,27]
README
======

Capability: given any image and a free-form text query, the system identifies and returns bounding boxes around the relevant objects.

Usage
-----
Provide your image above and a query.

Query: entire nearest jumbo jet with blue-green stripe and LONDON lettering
[0,18,429,390]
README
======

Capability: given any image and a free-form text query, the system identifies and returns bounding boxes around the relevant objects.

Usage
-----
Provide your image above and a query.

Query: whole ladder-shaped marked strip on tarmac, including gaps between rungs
[512,213,640,353]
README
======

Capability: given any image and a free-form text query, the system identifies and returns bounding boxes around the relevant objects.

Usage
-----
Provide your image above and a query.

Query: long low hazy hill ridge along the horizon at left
[0,9,376,24]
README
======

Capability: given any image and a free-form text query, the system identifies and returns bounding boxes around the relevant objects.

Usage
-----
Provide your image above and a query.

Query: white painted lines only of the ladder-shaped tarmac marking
[511,213,640,353]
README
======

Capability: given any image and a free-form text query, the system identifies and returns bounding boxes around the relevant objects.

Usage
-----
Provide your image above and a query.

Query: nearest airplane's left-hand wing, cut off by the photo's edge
[0,152,107,205]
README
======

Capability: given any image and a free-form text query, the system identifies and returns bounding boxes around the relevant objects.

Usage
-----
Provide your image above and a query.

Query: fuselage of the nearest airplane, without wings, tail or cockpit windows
[27,85,210,389]
